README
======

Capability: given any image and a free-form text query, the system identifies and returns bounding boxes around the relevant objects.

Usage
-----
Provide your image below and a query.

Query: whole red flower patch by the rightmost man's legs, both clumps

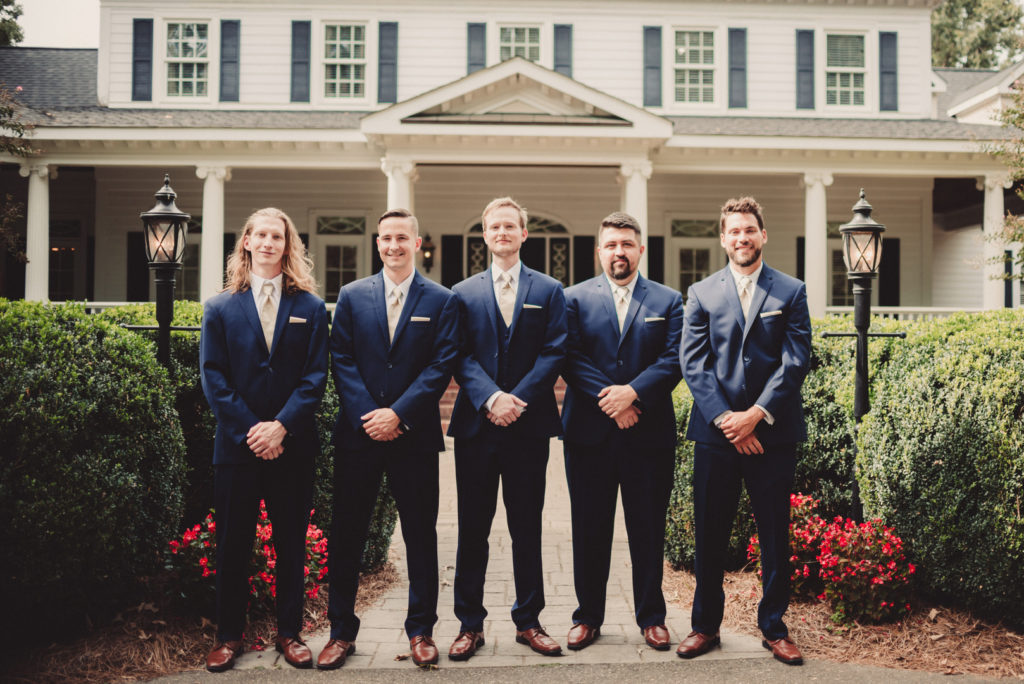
[746,494,916,623]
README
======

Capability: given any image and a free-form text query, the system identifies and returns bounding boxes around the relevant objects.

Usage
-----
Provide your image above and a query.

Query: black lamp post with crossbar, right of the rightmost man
[822,188,906,522]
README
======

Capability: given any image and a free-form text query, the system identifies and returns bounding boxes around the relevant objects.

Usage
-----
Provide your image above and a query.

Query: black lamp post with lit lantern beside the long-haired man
[139,175,191,370]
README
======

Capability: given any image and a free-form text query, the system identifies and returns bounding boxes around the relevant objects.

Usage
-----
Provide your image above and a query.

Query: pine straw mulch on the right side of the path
[665,564,1024,680]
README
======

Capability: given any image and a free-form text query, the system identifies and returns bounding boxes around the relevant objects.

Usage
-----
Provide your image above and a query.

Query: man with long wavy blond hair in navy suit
[200,208,328,672]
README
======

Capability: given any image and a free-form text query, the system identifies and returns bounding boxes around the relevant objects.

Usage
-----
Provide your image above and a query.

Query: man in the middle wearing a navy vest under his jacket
[449,198,566,660]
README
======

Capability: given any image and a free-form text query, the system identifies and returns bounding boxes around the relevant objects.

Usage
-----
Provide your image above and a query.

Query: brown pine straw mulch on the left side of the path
[0,562,398,684]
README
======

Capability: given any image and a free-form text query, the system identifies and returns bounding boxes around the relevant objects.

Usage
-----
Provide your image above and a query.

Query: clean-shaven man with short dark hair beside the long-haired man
[316,209,458,670]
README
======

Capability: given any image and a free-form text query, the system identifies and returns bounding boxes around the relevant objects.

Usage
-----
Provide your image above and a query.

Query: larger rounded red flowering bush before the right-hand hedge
[818,518,916,623]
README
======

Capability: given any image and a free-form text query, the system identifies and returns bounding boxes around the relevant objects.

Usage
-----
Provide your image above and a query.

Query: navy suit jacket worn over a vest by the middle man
[449,264,567,438]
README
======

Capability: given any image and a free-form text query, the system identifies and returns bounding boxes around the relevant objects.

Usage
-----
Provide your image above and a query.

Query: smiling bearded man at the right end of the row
[676,198,811,665]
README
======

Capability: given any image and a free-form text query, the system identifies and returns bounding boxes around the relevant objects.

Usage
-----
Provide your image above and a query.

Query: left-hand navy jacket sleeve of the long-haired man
[199,304,259,444]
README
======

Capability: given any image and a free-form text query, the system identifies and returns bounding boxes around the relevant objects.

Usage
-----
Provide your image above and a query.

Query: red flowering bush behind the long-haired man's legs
[169,501,327,612]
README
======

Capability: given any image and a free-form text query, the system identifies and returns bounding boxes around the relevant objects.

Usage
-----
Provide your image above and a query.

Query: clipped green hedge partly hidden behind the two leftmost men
[99,301,397,570]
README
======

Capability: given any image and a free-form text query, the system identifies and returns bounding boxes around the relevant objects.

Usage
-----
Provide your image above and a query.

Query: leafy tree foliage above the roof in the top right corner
[932,0,1024,69]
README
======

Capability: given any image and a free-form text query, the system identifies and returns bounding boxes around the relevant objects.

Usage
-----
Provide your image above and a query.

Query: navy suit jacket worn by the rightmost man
[680,264,811,446]
